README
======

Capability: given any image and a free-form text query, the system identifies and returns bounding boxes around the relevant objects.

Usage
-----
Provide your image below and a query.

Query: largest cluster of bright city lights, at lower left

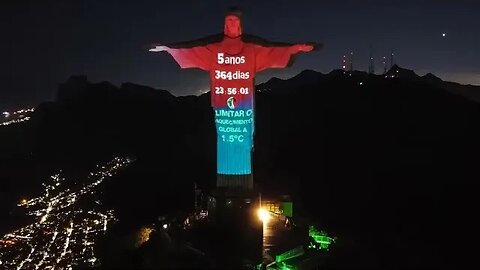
[0,157,133,270]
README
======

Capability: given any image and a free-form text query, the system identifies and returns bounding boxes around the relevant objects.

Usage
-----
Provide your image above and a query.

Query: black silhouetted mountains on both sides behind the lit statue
[0,66,480,269]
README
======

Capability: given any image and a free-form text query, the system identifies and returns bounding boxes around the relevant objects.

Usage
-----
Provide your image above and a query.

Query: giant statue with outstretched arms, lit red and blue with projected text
[150,7,314,190]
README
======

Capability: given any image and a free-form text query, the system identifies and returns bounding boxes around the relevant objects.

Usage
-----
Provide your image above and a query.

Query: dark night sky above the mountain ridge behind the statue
[0,0,480,110]
